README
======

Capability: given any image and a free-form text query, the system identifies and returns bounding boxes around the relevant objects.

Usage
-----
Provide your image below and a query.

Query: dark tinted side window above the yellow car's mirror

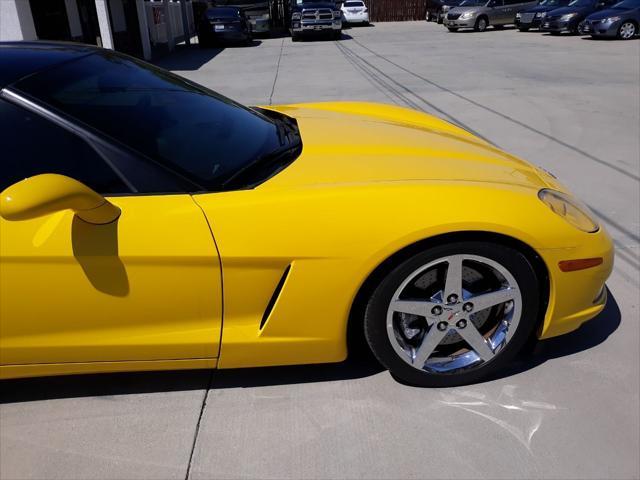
[0,100,130,194]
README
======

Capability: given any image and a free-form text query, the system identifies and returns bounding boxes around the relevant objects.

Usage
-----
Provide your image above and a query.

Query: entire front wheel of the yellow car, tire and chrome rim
[365,242,539,386]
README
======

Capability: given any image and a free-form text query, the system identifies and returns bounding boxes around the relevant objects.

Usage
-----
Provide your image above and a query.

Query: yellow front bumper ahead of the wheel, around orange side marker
[538,227,614,339]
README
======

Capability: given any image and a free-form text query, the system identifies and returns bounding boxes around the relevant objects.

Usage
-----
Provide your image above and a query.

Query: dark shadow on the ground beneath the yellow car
[0,292,621,404]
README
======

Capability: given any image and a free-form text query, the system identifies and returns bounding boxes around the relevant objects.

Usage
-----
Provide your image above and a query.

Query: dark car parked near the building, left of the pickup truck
[198,7,252,47]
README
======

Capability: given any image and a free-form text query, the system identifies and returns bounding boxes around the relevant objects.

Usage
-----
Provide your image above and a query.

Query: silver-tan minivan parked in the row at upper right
[444,0,538,32]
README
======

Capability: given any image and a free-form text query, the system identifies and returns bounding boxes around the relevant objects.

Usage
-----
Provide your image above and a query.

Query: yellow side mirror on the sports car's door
[0,173,120,225]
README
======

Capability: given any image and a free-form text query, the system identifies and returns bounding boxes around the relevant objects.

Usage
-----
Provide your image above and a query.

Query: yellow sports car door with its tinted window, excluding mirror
[0,98,222,365]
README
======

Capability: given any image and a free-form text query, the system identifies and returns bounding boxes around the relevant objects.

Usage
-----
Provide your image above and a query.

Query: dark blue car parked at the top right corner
[580,0,640,40]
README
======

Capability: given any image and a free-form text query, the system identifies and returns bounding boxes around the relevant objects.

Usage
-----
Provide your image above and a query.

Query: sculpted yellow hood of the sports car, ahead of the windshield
[261,102,552,188]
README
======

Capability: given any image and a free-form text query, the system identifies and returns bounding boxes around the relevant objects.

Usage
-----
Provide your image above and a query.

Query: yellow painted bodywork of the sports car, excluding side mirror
[0,103,613,376]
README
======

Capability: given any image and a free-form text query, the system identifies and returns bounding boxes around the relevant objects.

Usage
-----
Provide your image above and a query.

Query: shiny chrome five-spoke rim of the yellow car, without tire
[387,255,522,373]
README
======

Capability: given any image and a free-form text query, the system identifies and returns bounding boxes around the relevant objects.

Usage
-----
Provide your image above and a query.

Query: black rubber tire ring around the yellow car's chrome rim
[364,241,540,387]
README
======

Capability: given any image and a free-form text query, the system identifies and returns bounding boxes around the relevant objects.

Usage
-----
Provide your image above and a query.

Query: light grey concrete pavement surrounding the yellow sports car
[0,22,640,479]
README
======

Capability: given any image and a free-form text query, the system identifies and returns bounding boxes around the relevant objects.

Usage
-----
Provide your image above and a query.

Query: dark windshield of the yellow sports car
[16,51,281,190]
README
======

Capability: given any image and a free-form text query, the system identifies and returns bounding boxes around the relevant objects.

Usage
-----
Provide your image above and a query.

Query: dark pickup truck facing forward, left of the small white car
[291,0,342,42]
